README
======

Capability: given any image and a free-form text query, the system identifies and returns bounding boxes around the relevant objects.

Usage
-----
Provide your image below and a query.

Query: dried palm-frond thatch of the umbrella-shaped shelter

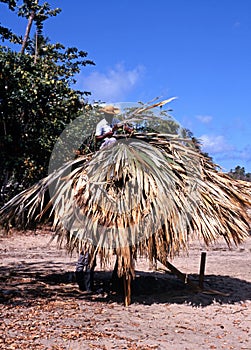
[0,100,251,305]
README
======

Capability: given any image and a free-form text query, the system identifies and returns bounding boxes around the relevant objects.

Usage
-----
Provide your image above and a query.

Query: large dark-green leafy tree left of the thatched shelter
[0,1,94,203]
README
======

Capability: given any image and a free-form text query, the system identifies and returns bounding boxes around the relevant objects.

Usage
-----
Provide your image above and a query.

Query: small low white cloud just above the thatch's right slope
[199,135,233,154]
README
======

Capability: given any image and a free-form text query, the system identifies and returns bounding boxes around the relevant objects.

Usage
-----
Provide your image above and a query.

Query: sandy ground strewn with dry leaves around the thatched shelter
[0,229,251,350]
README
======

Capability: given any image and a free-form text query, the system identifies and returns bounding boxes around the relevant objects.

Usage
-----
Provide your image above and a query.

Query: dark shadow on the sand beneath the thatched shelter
[0,261,251,307]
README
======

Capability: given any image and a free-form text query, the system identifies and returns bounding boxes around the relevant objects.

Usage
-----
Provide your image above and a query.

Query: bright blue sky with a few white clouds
[0,0,251,172]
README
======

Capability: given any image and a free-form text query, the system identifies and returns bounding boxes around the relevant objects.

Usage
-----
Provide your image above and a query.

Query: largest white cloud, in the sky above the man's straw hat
[83,64,144,102]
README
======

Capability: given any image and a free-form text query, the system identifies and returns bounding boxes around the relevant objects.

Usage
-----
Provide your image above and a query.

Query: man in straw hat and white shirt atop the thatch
[95,105,133,149]
